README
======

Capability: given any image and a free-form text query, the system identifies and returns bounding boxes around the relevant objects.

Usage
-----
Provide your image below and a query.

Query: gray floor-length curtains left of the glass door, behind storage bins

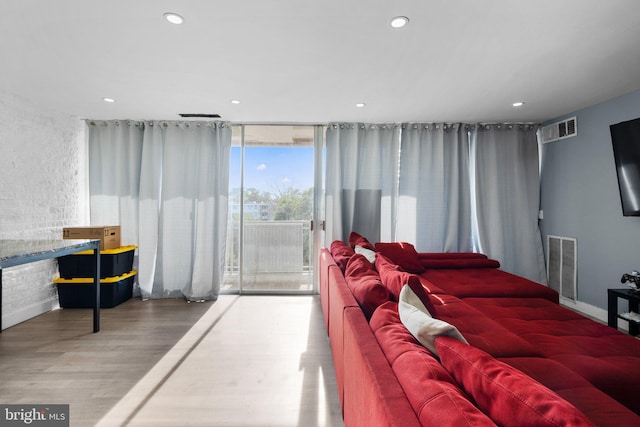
[88,120,231,300]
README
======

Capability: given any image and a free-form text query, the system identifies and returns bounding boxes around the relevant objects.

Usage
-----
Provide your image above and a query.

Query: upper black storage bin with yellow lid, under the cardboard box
[58,245,136,279]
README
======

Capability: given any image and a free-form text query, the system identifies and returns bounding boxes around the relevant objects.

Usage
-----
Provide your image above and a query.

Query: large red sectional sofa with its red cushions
[319,235,640,427]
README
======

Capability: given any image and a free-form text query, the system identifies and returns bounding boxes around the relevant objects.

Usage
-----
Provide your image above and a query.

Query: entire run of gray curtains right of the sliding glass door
[326,123,546,283]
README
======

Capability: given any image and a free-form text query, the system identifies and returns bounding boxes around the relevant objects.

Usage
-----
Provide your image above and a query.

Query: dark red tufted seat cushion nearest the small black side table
[464,298,640,414]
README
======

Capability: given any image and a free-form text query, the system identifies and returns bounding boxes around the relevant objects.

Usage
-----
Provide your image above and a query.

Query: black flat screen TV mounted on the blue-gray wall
[609,118,640,216]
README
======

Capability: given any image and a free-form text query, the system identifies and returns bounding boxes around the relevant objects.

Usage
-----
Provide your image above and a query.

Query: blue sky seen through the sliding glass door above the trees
[230,146,313,192]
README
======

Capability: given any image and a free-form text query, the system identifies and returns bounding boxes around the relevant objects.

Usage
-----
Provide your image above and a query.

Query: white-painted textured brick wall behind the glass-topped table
[0,93,88,328]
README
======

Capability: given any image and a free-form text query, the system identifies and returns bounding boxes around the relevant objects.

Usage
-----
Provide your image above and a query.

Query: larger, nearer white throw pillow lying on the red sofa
[398,285,468,356]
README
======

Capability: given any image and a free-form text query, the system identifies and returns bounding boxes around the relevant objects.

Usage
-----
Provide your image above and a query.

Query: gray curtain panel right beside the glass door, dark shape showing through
[325,123,400,245]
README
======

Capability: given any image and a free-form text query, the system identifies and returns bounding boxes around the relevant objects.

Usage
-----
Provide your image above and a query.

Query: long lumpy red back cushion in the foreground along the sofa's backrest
[370,301,495,426]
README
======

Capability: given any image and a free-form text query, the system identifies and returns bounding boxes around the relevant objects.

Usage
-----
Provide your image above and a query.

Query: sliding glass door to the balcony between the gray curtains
[224,125,321,293]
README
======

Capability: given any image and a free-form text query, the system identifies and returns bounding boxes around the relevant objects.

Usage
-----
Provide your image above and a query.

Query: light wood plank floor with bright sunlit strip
[0,296,342,427]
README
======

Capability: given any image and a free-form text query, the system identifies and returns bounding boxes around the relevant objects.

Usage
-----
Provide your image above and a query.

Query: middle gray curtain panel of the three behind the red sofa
[397,123,473,252]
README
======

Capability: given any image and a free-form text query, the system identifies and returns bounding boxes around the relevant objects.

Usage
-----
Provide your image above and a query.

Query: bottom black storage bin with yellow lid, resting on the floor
[54,270,137,308]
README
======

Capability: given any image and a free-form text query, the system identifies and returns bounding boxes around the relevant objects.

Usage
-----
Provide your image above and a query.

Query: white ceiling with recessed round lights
[0,0,640,124]
